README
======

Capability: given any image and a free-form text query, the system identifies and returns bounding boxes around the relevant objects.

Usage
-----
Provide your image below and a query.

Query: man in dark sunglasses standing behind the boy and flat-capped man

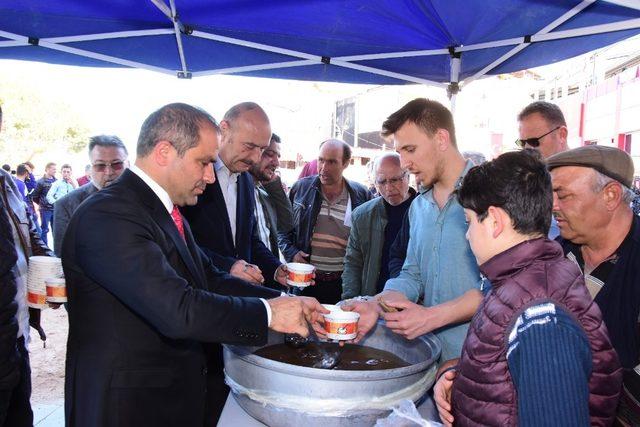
[516,101,569,239]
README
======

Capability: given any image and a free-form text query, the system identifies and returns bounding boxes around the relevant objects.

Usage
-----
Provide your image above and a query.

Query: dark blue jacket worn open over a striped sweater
[278,175,371,261]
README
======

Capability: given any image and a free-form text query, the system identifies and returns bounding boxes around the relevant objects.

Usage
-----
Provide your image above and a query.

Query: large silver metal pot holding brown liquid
[224,322,440,427]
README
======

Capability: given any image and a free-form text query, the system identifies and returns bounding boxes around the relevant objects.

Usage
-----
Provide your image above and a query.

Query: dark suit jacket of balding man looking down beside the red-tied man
[181,172,280,288]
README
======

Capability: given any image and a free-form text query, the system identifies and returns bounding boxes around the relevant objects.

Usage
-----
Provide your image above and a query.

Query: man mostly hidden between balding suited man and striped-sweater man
[249,133,293,257]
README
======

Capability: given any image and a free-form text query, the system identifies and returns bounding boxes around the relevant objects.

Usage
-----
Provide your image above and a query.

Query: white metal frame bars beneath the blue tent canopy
[0,0,640,101]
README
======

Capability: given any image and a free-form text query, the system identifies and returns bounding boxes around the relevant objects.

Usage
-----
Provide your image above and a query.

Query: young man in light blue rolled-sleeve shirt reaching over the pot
[347,98,482,360]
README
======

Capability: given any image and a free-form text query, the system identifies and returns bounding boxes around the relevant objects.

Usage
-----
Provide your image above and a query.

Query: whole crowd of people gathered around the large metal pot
[0,98,640,426]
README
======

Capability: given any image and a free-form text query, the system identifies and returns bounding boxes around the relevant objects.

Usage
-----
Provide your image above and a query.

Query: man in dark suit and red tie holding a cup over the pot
[62,104,326,427]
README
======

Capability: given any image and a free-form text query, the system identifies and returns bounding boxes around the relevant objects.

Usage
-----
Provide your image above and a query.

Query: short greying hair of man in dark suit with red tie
[136,103,220,157]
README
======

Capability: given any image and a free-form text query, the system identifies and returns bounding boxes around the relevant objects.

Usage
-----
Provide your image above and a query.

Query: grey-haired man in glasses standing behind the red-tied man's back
[53,135,128,256]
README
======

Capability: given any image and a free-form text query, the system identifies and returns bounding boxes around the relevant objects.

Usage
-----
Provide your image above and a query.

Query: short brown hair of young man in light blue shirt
[381,98,457,146]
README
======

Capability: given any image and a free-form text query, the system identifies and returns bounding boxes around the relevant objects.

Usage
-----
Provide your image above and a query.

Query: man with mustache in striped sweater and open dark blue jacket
[280,139,371,304]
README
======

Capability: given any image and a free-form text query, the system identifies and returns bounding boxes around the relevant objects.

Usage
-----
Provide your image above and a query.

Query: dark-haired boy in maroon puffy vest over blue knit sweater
[434,150,621,427]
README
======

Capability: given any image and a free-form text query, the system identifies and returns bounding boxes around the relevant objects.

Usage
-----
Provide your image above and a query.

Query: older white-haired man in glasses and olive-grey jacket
[342,153,416,299]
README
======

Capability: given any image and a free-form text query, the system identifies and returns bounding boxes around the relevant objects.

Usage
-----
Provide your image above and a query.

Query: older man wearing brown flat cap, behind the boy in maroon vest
[547,145,640,425]
